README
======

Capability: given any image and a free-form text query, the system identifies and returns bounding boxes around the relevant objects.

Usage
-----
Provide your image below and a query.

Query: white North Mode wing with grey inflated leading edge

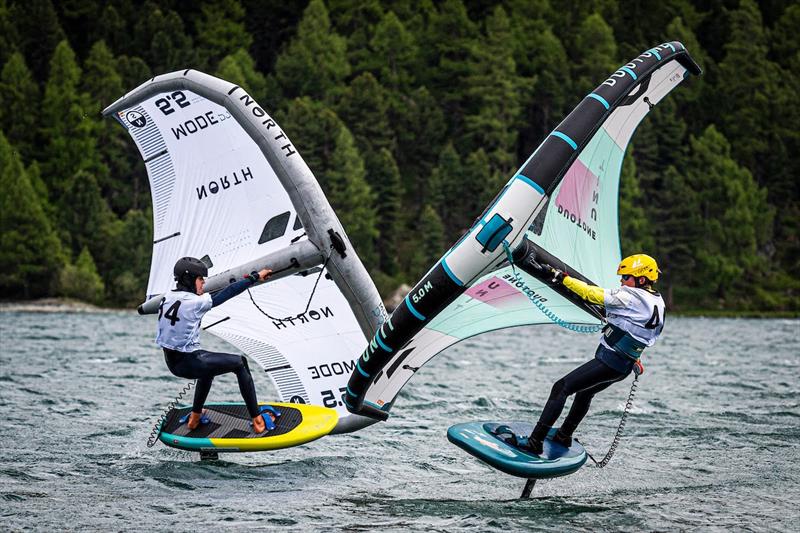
[104,70,386,432]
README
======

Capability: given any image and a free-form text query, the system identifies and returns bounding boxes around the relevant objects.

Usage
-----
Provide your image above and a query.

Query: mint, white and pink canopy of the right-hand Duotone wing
[356,54,687,411]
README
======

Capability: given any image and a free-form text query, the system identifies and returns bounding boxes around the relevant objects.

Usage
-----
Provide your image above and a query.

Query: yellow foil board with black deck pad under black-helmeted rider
[159,403,339,452]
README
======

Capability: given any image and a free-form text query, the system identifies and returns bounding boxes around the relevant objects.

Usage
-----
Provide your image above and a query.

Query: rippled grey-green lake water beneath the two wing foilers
[0,311,800,531]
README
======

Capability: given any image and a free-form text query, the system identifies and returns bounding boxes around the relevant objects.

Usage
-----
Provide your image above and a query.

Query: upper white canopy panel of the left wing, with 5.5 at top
[118,90,302,296]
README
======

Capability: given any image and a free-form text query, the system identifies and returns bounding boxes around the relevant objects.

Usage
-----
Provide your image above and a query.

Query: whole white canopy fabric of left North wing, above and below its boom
[116,89,367,430]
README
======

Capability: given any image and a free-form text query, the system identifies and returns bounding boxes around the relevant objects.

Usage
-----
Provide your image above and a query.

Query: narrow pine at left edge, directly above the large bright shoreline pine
[0,52,39,161]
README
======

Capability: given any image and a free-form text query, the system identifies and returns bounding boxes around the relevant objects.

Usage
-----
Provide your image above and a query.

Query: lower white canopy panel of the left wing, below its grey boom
[204,274,366,417]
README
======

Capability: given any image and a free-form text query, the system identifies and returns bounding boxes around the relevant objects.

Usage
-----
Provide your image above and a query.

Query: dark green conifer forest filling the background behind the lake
[0,0,800,313]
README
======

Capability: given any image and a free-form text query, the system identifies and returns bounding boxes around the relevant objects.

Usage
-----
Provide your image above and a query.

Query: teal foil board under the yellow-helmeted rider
[447,422,587,479]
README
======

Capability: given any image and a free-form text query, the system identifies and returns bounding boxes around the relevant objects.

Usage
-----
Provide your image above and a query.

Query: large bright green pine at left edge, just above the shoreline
[0,132,64,298]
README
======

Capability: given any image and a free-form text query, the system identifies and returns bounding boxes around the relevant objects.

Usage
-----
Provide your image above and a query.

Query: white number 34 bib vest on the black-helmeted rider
[156,291,213,352]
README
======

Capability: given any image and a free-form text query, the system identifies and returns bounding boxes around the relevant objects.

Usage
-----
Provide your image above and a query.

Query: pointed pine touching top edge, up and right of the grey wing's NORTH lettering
[275,0,350,101]
